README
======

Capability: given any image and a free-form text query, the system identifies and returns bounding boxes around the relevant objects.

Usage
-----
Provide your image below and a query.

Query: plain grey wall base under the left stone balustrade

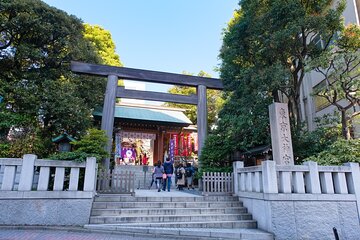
[0,198,92,226]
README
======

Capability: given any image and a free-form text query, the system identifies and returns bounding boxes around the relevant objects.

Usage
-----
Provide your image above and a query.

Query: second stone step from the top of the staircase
[92,201,243,209]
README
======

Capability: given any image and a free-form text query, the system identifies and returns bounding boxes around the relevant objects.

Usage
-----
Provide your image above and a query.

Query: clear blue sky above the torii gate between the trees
[44,0,238,89]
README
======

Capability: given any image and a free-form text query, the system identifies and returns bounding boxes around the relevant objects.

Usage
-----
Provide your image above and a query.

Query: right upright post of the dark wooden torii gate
[197,85,208,165]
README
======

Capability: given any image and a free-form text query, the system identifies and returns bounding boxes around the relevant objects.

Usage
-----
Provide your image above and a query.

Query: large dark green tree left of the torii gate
[0,0,106,157]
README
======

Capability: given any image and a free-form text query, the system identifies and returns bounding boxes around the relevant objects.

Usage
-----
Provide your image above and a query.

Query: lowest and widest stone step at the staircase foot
[85,224,274,240]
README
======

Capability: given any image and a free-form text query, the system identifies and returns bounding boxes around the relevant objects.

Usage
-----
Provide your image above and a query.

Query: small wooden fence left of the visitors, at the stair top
[97,170,135,195]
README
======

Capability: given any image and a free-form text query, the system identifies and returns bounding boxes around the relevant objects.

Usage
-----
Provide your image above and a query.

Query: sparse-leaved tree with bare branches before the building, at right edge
[309,25,360,139]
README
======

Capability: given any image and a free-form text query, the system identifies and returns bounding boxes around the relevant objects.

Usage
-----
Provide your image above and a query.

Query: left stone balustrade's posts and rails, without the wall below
[0,154,96,195]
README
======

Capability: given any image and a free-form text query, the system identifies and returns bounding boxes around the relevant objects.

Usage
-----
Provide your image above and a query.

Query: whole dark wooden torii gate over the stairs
[71,61,223,169]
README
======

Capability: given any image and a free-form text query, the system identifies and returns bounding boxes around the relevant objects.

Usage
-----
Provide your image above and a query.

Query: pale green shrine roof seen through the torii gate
[93,104,192,126]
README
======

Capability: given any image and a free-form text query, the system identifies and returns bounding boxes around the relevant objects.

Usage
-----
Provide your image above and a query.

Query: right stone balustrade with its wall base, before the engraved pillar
[233,161,360,239]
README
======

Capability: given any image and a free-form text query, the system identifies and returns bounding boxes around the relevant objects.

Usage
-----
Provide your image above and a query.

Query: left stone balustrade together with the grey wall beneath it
[0,154,97,225]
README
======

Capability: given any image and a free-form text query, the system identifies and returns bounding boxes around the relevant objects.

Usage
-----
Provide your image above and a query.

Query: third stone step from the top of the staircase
[91,207,247,216]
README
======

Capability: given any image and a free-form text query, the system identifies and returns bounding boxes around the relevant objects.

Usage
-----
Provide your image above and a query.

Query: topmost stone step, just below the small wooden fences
[94,194,239,202]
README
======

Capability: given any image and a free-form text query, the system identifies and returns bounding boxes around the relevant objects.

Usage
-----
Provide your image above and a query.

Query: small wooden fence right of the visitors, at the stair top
[202,172,234,196]
